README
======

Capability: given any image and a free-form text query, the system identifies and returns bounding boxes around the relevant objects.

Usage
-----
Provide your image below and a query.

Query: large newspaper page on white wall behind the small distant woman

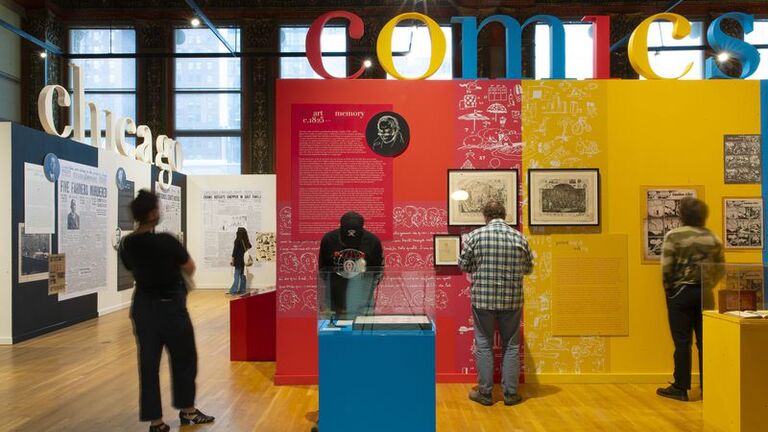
[202,190,264,269]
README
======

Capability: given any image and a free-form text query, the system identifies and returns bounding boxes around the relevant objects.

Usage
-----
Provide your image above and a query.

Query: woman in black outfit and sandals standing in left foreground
[120,190,214,432]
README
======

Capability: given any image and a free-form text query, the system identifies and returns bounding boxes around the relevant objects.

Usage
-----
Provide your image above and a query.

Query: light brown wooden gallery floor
[0,291,713,432]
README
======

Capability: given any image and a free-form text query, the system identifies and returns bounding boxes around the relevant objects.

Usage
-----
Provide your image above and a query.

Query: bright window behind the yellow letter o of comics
[387,26,453,80]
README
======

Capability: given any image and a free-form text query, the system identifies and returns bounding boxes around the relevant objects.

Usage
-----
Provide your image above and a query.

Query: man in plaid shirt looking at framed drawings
[459,201,533,406]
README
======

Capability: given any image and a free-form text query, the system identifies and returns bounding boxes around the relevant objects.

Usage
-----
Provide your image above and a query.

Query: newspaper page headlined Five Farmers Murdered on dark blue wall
[59,161,108,300]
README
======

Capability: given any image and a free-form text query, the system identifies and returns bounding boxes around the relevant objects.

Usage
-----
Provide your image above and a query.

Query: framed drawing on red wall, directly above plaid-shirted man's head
[448,169,518,226]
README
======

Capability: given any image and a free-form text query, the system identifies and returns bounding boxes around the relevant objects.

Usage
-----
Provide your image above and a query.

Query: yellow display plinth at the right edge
[703,311,768,431]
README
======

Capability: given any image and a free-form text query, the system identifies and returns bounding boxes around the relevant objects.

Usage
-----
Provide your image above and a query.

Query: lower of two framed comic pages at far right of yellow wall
[723,197,763,249]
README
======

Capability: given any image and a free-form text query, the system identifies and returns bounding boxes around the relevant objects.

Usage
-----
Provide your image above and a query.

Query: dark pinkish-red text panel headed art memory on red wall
[291,104,392,241]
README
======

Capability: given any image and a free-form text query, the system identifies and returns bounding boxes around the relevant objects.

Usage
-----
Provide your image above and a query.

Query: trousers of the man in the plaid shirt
[472,306,523,395]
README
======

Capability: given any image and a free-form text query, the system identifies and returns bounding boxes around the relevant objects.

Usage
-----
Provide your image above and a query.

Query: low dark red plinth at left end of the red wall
[229,290,277,361]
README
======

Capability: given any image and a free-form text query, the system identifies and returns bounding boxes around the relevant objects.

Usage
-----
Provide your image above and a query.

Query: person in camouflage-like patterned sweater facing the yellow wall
[656,198,725,401]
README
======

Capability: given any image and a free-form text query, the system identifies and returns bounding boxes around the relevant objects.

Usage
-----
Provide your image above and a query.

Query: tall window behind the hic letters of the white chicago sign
[69,29,136,145]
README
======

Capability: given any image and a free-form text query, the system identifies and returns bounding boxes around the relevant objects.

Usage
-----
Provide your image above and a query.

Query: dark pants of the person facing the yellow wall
[667,285,704,390]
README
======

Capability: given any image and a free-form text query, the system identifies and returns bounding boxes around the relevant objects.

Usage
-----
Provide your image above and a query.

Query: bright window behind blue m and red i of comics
[534,23,595,79]
